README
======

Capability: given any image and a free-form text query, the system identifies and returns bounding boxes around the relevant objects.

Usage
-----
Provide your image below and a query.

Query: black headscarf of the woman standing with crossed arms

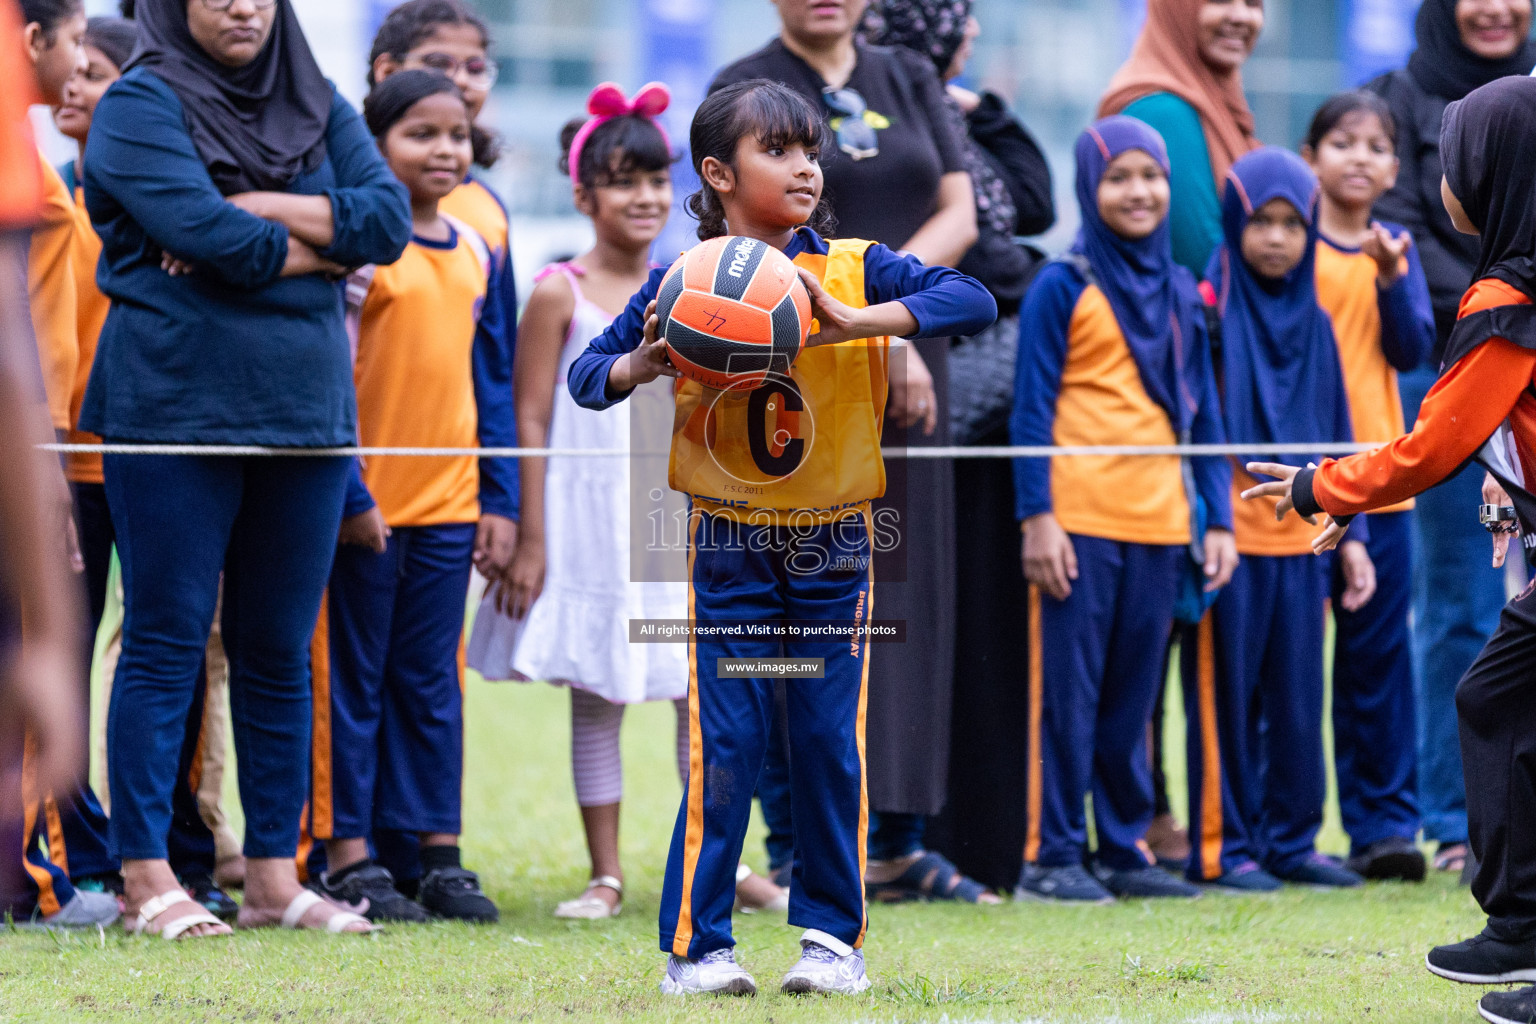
[127,0,330,195]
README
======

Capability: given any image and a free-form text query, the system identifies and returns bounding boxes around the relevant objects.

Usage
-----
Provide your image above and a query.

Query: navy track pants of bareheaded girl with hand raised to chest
[1332,511,1419,855]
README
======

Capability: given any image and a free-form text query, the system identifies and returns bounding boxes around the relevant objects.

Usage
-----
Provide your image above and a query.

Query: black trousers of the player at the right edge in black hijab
[1456,582,1536,943]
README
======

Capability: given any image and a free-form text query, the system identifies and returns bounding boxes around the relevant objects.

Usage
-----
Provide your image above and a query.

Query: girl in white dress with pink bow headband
[468,84,688,918]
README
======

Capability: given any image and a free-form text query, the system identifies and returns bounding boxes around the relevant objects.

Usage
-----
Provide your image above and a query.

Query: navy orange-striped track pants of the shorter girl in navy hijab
[1181,554,1329,881]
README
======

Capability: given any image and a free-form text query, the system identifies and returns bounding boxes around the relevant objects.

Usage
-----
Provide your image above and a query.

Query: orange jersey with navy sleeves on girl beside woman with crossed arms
[344,221,518,527]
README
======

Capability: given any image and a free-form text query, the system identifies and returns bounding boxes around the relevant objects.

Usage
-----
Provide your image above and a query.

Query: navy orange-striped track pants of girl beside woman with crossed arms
[310,524,475,840]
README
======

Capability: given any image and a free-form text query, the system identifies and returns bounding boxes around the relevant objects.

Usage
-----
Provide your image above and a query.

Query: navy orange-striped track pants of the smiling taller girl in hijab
[1025,534,1189,870]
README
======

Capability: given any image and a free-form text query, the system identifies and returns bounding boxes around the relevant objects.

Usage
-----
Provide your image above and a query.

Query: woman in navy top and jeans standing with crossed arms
[80,0,410,938]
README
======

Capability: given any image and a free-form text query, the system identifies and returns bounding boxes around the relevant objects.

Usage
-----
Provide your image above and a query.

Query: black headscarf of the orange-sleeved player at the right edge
[1441,75,1536,301]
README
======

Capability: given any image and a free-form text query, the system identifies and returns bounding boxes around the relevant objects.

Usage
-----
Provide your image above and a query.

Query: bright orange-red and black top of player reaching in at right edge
[1293,278,1536,531]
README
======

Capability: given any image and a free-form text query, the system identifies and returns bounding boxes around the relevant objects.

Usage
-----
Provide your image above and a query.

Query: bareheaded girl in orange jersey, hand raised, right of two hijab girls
[1301,92,1435,881]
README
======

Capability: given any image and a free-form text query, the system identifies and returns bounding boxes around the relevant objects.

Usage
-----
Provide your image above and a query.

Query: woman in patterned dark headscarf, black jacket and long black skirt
[865,0,1055,890]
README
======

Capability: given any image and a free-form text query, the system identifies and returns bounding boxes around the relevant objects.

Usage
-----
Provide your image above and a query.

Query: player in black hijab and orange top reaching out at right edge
[1244,77,1536,1022]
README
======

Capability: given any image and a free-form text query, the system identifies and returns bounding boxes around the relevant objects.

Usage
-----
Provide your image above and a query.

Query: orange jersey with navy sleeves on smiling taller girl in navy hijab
[1009,261,1232,545]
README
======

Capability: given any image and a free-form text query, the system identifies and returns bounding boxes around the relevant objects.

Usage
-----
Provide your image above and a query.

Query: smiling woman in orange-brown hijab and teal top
[1098,0,1264,276]
